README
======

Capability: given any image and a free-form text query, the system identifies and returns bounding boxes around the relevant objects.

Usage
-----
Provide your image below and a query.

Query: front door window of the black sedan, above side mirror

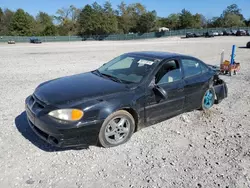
[155,60,182,84]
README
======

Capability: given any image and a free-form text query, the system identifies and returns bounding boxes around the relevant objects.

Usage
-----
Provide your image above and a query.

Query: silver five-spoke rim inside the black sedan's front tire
[105,116,130,144]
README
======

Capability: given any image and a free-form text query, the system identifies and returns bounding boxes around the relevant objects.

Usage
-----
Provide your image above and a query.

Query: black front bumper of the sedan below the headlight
[25,102,103,148]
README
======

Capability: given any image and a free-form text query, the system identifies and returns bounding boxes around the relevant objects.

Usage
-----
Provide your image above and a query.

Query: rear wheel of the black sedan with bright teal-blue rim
[201,88,215,111]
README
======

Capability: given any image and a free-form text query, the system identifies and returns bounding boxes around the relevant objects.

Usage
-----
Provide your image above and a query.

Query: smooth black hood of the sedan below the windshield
[34,72,127,105]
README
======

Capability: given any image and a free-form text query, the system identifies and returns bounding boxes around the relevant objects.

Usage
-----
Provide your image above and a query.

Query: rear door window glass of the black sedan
[182,59,202,77]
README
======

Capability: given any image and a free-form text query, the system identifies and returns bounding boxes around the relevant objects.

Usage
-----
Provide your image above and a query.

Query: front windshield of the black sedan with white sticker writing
[98,55,159,83]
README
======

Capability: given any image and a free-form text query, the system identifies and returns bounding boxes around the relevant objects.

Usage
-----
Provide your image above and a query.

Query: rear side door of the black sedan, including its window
[181,58,208,110]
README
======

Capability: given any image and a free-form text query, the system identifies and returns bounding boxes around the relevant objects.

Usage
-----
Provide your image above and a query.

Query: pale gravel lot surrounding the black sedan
[0,37,250,188]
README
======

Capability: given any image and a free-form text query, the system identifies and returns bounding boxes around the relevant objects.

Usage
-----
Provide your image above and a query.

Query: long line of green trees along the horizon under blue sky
[0,1,250,36]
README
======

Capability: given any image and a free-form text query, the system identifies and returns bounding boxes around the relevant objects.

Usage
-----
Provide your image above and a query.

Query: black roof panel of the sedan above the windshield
[126,51,185,60]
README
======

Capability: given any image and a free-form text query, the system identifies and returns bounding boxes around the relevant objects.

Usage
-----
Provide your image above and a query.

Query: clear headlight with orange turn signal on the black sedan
[49,109,84,121]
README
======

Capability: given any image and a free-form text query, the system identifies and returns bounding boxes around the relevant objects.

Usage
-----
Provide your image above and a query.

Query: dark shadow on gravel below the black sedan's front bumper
[15,112,89,152]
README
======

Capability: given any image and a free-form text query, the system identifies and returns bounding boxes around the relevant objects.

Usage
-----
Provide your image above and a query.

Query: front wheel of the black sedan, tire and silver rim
[98,110,135,148]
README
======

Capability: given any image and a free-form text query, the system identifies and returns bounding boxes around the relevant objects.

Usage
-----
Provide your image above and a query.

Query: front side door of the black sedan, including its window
[145,59,185,125]
